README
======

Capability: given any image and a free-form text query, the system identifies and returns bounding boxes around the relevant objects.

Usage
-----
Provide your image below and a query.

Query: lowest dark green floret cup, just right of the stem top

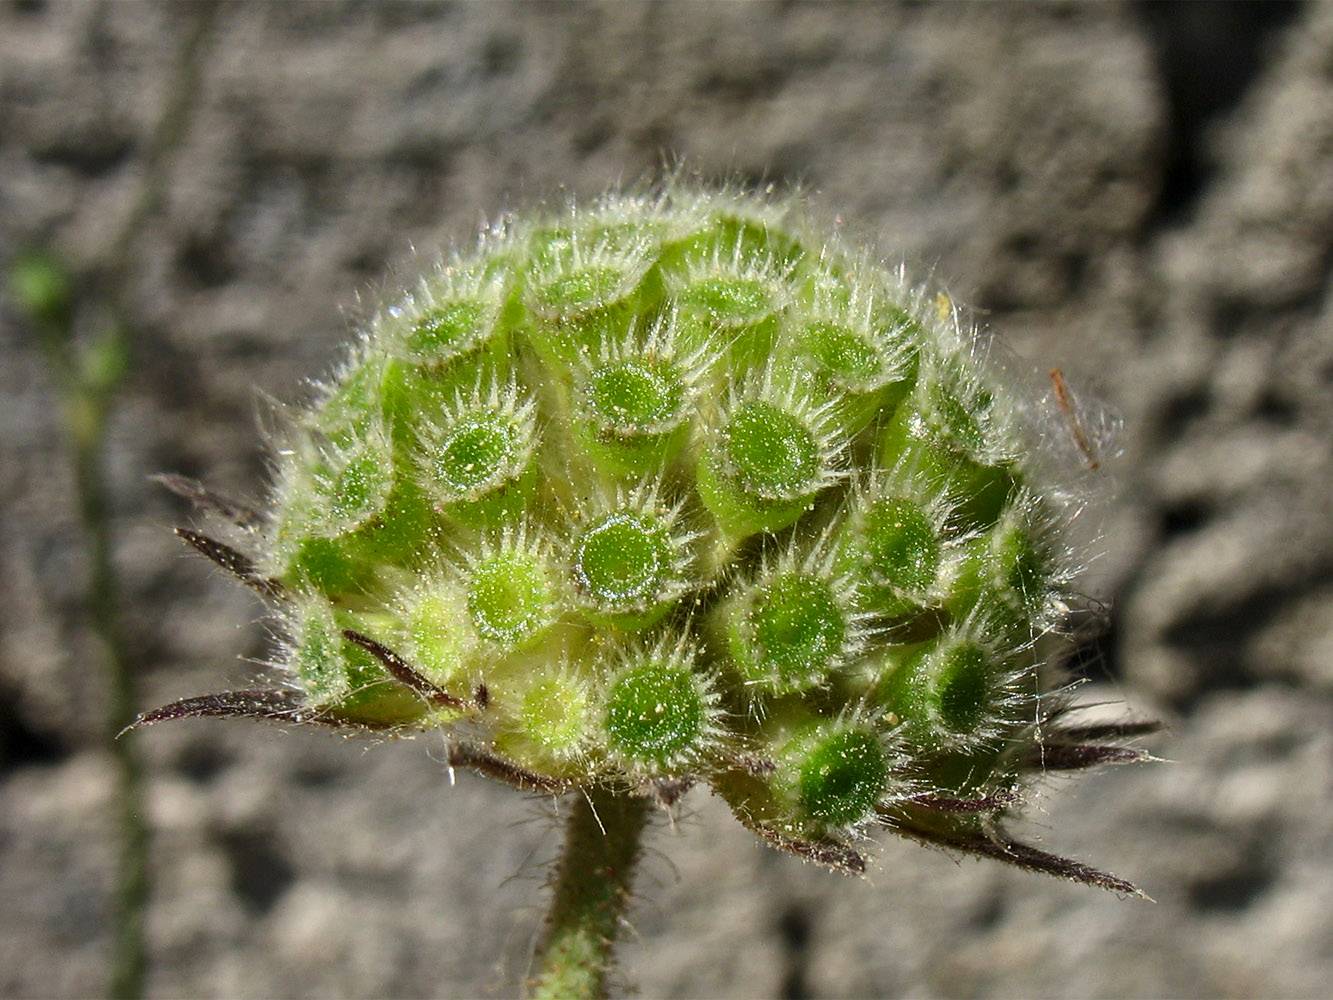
[781,724,889,827]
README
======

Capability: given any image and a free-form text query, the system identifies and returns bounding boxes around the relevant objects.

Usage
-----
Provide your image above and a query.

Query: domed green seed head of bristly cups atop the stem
[143,179,1146,873]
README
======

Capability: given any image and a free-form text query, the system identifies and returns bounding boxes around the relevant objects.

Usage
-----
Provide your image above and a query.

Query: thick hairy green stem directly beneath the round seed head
[532,788,649,1000]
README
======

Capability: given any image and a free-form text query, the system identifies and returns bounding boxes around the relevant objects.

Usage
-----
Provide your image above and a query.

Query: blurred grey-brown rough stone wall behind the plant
[0,0,1333,999]
